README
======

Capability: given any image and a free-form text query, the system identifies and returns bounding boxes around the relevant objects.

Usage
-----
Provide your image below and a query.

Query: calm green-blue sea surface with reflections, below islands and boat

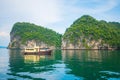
[0,48,120,80]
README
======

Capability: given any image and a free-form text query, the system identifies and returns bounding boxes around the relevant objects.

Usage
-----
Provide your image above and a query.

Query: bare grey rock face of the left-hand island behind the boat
[8,35,55,49]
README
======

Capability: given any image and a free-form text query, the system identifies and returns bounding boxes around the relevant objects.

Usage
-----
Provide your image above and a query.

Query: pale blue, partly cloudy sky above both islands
[0,0,120,46]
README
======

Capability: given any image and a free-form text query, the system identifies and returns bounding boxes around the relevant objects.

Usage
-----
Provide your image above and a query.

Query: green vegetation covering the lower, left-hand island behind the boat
[10,22,62,47]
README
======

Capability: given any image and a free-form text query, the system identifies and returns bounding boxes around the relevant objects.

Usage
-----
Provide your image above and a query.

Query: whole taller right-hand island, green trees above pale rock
[61,15,120,49]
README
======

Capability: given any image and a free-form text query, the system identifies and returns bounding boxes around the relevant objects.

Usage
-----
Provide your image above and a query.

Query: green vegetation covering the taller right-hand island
[63,15,120,48]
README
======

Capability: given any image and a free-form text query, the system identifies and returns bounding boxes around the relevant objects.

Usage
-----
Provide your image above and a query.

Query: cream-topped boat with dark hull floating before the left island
[24,47,52,54]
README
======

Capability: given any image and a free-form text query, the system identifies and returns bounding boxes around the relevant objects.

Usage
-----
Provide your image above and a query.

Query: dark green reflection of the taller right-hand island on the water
[62,50,120,80]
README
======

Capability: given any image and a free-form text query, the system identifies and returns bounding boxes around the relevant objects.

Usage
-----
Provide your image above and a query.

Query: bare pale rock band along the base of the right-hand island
[61,39,117,49]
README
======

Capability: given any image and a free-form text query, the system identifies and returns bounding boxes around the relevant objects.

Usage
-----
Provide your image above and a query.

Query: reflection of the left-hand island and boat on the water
[8,50,54,80]
